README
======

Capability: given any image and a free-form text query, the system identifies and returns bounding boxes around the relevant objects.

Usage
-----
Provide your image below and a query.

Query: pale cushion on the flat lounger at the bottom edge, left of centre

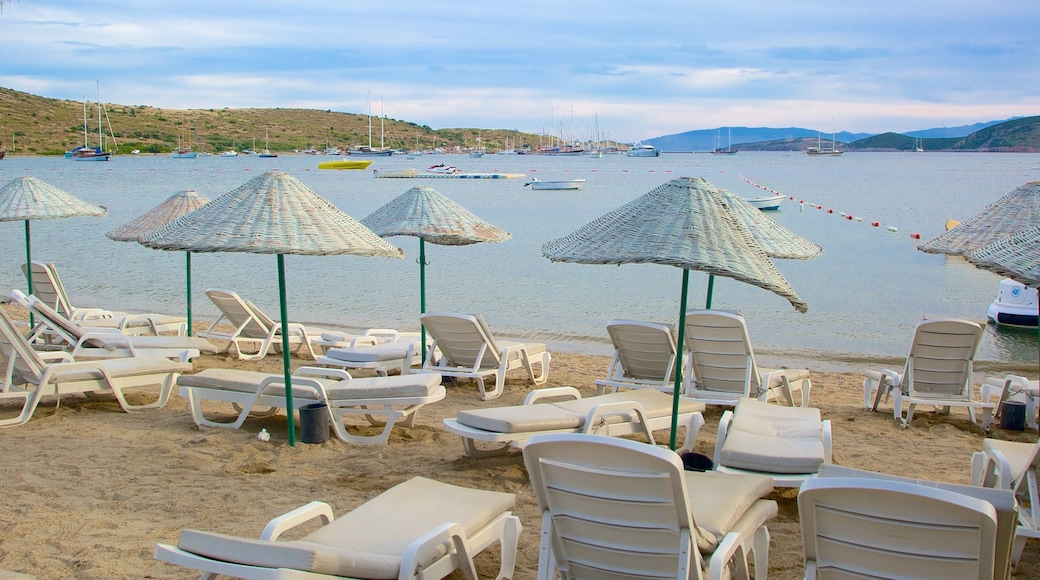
[178,477,516,578]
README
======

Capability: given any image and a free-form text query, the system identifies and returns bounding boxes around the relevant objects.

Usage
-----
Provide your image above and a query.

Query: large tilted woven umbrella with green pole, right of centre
[542,178,809,449]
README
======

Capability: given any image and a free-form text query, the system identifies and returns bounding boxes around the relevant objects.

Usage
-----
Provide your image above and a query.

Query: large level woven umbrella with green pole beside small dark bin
[140,172,404,446]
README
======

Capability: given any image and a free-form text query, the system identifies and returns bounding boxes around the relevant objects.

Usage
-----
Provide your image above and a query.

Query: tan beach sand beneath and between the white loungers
[0,307,1040,580]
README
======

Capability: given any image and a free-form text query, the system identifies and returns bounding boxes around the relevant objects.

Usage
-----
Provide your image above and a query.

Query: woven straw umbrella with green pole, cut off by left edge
[0,177,108,301]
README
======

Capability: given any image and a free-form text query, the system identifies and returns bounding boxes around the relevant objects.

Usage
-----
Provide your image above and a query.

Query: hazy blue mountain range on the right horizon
[644,116,1040,152]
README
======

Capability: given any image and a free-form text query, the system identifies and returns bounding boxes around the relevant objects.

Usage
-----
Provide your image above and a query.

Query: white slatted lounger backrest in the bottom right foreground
[798,477,997,579]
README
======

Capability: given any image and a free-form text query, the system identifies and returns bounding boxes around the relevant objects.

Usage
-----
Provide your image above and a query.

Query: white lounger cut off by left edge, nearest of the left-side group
[0,310,191,427]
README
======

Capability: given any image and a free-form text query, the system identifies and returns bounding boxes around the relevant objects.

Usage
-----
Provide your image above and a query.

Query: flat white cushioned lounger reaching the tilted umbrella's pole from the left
[444,387,704,457]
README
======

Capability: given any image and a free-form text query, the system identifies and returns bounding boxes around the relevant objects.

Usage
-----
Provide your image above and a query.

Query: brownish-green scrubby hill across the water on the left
[0,87,539,155]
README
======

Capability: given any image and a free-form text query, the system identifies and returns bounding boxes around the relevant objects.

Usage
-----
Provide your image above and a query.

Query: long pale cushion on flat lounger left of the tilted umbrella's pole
[457,389,704,433]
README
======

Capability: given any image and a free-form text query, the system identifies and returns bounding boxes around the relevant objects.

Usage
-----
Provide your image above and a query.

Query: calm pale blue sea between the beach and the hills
[0,152,1040,369]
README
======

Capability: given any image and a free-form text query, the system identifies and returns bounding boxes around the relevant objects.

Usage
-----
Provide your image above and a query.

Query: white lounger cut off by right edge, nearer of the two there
[971,438,1040,564]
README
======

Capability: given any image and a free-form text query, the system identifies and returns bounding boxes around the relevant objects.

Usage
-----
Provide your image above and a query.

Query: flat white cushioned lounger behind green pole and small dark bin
[177,367,445,445]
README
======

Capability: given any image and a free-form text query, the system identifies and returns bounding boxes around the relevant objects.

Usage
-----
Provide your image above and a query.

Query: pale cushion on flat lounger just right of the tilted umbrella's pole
[721,400,825,473]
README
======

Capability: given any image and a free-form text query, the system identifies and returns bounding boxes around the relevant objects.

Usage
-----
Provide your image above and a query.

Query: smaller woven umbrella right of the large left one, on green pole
[361,186,511,360]
